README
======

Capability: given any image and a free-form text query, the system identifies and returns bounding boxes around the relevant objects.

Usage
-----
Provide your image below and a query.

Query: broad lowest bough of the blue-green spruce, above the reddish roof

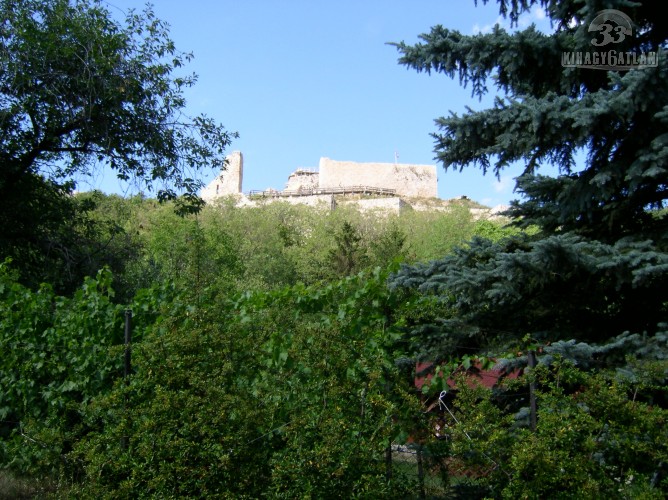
[391,234,668,359]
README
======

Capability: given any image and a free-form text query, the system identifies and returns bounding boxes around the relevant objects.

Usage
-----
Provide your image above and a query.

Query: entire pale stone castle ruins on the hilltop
[201,151,438,210]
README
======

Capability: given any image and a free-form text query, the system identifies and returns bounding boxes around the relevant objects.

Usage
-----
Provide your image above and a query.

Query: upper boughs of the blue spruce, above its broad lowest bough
[397,0,668,241]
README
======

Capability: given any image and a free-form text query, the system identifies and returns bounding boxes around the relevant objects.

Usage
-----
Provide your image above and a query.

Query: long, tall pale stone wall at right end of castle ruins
[319,158,438,198]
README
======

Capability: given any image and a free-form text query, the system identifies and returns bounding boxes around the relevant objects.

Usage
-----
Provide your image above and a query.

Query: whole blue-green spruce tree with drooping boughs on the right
[390,0,668,366]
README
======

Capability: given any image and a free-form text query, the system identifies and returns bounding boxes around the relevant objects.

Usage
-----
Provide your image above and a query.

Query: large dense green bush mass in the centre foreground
[66,274,422,497]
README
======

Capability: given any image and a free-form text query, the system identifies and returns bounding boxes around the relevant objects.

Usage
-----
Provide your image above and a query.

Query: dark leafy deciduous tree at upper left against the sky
[0,0,234,288]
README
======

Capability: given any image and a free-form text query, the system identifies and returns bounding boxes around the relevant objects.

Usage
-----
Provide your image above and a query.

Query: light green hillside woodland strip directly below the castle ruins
[126,195,485,289]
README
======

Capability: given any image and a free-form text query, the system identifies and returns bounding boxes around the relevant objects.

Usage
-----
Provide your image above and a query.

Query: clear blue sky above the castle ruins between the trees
[95,0,549,206]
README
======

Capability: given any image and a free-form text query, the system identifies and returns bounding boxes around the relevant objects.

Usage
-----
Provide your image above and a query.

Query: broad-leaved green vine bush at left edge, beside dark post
[0,263,123,472]
